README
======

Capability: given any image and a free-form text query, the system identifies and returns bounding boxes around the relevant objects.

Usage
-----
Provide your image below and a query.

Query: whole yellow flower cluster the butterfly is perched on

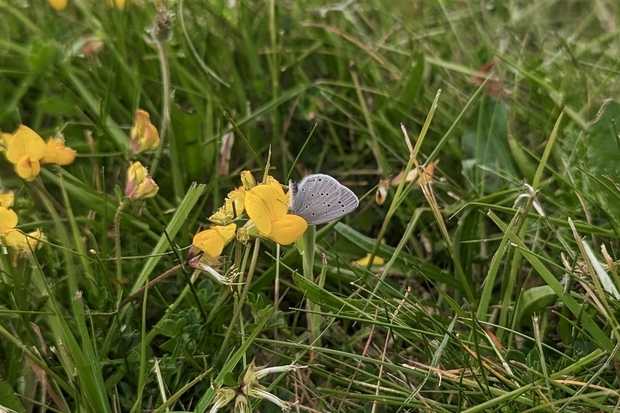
[192,171,308,261]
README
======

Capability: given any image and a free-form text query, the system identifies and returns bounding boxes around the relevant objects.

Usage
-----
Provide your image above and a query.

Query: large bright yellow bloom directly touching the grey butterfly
[245,178,308,245]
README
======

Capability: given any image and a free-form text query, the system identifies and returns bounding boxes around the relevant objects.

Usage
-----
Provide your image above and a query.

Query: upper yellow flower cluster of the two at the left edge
[0,125,76,182]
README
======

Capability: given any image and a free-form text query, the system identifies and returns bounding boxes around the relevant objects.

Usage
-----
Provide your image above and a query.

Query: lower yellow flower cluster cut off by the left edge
[0,191,46,258]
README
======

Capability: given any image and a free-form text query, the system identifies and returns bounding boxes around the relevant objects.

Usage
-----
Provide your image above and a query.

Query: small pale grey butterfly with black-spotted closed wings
[289,174,359,225]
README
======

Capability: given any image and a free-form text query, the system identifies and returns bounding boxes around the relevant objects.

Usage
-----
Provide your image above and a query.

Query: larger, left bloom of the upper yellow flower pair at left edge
[4,125,46,181]
